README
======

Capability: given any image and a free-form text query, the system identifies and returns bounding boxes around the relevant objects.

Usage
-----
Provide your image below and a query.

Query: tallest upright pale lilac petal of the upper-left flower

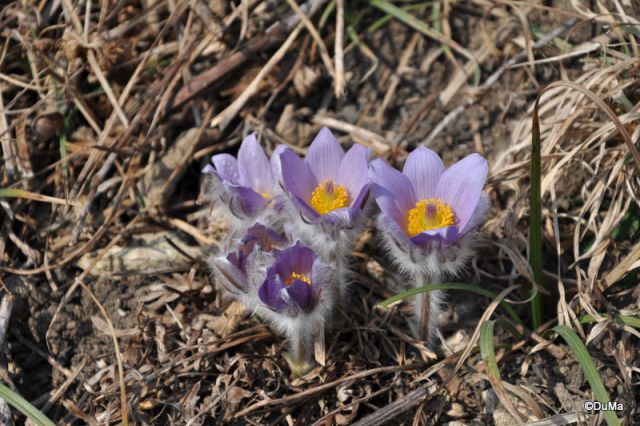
[238,133,274,194]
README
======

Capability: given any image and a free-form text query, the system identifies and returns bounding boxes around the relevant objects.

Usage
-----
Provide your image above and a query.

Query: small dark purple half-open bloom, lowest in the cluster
[258,241,326,316]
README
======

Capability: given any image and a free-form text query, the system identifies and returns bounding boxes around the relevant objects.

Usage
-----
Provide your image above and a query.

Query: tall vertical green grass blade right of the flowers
[529,94,543,331]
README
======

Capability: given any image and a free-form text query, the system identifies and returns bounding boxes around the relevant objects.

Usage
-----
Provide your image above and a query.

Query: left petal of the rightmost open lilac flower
[370,159,416,229]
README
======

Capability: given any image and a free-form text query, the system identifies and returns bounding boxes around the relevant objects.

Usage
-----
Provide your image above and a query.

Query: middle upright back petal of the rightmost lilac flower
[402,146,444,200]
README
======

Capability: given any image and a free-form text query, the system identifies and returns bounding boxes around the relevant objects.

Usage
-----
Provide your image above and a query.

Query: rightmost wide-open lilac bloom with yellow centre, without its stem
[371,147,488,247]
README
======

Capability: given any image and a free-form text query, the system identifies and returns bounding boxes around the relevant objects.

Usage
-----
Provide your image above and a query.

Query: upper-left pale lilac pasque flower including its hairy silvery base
[203,133,283,228]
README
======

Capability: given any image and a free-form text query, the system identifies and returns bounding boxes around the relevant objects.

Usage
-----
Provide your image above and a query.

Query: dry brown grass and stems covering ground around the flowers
[0,0,640,425]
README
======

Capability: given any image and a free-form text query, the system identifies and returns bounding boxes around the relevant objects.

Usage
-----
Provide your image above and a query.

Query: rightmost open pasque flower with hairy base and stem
[371,147,489,342]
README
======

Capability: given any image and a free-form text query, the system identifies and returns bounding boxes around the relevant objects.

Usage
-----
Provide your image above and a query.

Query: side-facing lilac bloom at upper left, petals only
[203,133,279,218]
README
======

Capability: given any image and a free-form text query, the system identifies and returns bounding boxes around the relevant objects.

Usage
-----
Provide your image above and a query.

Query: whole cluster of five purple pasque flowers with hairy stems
[204,128,488,375]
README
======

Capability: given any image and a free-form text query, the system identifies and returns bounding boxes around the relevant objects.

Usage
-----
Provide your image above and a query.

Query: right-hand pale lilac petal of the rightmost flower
[436,154,489,233]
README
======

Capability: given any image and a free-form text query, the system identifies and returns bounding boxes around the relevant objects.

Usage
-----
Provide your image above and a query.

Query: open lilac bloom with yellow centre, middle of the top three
[280,127,369,225]
